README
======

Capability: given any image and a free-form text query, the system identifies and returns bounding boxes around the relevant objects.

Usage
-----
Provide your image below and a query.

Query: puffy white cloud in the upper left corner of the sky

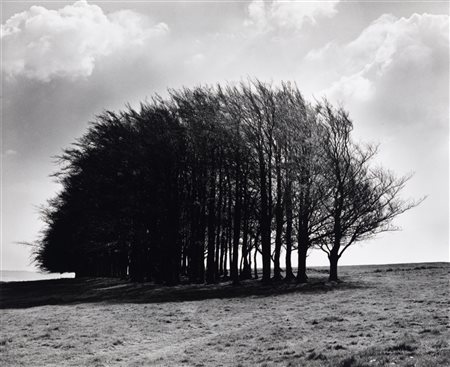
[1,0,168,81]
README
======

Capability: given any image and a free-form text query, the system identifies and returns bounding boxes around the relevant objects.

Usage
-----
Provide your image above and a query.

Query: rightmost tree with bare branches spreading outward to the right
[318,101,421,281]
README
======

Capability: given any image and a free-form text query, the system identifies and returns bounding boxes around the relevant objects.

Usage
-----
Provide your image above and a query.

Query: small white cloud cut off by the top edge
[244,0,339,31]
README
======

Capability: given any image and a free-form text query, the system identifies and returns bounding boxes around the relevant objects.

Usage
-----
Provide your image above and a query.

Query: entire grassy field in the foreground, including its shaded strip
[0,263,450,367]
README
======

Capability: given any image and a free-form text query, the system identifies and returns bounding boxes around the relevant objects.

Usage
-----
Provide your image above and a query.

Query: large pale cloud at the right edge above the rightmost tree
[306,14,449,118]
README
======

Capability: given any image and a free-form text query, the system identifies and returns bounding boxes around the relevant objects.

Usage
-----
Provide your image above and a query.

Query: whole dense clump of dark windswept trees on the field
[35,81,417,284]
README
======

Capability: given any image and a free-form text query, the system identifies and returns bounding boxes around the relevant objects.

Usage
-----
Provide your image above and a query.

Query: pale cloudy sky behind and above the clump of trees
[1,0,450,270]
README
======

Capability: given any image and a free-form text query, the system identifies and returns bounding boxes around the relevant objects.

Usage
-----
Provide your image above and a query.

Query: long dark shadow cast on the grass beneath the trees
[0,277,368,309]
